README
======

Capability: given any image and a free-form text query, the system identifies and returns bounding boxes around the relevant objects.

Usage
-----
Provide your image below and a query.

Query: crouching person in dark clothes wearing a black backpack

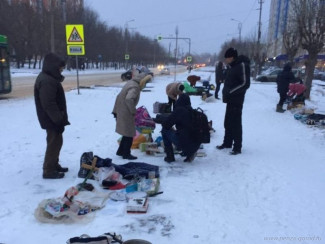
[161,93,201,163]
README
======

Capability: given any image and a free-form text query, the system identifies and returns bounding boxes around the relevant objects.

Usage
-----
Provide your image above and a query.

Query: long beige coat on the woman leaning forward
[113,80,141,137]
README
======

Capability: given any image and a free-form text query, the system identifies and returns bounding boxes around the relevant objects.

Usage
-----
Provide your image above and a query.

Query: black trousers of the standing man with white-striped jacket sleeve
[223,103,243,151]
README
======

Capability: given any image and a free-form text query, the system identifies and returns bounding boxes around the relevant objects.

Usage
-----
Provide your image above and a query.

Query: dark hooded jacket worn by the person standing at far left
[34,53,70,133]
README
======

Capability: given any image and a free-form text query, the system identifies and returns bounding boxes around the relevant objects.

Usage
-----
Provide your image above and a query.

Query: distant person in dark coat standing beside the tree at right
[276,63,295,113]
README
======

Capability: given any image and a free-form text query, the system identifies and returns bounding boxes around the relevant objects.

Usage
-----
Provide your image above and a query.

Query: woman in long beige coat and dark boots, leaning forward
[112,69,145,160]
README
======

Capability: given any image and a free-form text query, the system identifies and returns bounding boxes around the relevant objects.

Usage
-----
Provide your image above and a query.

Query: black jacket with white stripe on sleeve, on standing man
[222,55,250,104]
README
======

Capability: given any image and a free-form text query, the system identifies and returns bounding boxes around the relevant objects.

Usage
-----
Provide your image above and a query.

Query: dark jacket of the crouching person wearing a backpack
[162,94,201,156]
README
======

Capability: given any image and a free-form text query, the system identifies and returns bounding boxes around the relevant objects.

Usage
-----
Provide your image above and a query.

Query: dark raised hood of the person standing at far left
[42,53,65,82]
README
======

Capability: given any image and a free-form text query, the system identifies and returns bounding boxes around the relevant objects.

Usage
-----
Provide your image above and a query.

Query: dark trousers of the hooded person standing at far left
[43,130,63,173]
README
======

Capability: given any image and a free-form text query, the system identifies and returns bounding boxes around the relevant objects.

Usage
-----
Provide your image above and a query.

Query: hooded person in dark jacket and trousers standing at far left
[34,53,70,179]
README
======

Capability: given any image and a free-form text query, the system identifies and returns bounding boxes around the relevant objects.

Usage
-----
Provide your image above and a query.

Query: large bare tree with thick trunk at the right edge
[290,0,325,99]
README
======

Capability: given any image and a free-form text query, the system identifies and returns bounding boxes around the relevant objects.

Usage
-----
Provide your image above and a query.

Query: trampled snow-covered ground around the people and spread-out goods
[0,67,325,244]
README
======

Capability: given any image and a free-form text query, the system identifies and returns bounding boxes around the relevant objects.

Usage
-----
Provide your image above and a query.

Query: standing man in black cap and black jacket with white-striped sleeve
[217,48,250,155]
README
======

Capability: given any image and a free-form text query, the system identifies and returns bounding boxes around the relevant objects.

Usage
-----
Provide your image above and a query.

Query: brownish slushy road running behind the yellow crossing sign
[0,66,186,99]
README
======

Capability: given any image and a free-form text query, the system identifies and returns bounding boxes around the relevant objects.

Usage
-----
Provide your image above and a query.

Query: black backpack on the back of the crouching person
[191,108,210,143]
